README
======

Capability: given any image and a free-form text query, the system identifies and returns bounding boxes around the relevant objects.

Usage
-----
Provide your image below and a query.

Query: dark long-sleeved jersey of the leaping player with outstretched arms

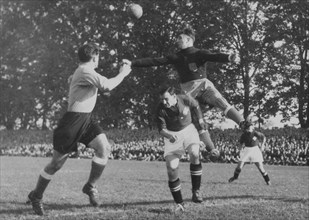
[132,47,229,83]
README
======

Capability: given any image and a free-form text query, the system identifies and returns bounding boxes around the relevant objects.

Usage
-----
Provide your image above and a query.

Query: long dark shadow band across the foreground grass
[0,195,309,215]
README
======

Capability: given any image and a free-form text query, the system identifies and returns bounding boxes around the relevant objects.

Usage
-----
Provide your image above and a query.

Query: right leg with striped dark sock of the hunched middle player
[188,144,203,203]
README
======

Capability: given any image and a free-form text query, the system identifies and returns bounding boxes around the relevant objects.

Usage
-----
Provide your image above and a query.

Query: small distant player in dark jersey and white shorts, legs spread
[229,119,270,185]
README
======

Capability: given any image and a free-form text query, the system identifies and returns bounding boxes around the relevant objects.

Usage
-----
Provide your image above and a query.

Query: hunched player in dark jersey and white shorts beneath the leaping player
[157,87,206,212]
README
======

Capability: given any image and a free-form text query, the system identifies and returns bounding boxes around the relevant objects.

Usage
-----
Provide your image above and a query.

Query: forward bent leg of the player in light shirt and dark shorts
[82,134,110,206]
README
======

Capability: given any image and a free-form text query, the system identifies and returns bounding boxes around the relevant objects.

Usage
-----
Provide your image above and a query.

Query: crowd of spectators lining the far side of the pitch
[0,128,309,166]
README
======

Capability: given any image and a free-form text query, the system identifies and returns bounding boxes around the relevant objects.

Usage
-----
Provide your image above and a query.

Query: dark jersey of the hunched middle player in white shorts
[157,95,202,131]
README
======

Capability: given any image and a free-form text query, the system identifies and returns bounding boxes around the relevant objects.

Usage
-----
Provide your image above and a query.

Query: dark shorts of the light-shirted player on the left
[53,112,104,154]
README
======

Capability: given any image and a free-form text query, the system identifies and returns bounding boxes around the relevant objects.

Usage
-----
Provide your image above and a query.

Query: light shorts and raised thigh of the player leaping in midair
[180,79,231,111]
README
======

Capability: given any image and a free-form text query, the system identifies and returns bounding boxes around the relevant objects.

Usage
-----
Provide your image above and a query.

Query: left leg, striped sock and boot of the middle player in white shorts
[165,155,184,214]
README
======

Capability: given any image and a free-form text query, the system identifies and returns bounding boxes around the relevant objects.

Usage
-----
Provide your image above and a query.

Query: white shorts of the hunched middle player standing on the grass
[164,124,200,157]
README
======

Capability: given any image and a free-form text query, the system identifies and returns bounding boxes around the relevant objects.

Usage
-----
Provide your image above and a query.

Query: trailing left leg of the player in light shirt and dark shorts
[27,150,69,215]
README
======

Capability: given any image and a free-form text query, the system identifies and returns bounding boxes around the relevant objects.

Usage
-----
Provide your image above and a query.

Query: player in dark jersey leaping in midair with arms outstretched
[123,28,244,158]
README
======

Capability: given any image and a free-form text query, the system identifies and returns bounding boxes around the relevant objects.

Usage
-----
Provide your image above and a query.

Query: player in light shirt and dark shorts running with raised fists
[28,43,131,215]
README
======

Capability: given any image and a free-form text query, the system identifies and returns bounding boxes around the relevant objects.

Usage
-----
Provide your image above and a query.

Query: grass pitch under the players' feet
[0,156,309,220]
